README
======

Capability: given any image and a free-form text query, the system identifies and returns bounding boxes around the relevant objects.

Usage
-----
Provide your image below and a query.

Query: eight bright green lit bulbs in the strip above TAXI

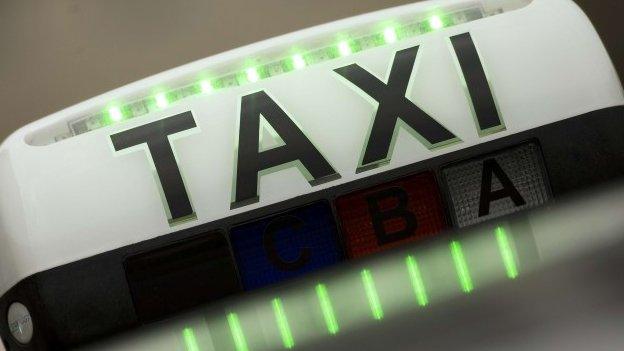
[107,15,444,122]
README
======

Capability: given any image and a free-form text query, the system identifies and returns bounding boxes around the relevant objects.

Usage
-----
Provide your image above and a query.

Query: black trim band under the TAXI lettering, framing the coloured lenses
[0,106,624,351]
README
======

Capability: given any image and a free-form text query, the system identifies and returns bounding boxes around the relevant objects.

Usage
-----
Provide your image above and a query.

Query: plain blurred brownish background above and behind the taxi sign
[0,0,624,140]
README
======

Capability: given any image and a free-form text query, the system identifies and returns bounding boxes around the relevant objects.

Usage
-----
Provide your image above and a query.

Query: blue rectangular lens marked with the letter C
[230,202,342,290]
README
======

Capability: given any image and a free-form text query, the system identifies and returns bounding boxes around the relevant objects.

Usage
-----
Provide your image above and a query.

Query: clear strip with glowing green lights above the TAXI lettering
[55,6,496,141]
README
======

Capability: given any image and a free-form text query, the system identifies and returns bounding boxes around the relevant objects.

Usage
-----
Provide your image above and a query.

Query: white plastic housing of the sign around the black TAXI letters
[0,0,624,294]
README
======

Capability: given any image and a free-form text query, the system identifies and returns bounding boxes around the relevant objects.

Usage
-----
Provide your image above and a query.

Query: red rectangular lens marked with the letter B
[336,172,447,258]
